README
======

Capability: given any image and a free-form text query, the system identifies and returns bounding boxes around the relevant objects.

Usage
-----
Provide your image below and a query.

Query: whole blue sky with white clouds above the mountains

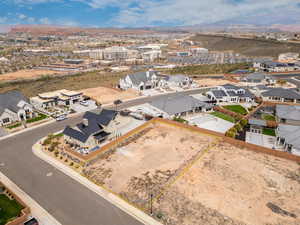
[0,0,300,27]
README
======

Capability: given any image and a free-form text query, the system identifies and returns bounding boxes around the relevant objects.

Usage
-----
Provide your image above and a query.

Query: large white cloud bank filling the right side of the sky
[77,0,300,26]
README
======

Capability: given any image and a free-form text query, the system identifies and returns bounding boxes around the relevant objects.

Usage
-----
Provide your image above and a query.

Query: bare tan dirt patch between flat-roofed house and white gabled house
[81,87,138,104]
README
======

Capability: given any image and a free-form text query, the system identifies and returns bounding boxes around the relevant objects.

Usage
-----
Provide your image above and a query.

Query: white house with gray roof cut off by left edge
[0,91,34,126]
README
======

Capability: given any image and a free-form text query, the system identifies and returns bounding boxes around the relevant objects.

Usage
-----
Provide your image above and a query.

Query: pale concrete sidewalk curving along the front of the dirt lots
[32,140,162,225]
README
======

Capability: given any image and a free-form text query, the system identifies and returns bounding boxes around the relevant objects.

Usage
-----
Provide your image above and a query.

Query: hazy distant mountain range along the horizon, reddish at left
[0,23,300,35]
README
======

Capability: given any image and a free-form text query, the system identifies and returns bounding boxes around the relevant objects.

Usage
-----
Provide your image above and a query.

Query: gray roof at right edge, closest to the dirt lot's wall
[277,124,300,149]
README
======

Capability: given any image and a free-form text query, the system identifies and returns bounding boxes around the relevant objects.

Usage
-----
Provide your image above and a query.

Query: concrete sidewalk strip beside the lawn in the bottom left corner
[0,172,61,225]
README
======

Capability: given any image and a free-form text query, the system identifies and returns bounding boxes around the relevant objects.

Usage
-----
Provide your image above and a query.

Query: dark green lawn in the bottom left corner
[0,194,23,225]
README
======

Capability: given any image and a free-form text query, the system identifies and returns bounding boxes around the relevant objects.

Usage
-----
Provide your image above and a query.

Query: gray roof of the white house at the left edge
[0,91,29,114]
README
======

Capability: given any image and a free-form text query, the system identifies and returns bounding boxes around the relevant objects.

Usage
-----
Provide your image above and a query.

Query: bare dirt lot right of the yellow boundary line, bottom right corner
[154,142,300,225]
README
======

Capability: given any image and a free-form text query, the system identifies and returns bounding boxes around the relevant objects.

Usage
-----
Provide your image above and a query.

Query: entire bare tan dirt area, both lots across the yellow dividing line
[84,119,300,225]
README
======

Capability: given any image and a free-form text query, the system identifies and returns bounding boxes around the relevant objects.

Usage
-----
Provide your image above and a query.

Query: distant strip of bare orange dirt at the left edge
[0,70,62,81]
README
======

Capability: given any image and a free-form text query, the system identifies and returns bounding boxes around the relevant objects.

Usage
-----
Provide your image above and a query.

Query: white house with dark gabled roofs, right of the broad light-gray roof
[206,84,255,103]
